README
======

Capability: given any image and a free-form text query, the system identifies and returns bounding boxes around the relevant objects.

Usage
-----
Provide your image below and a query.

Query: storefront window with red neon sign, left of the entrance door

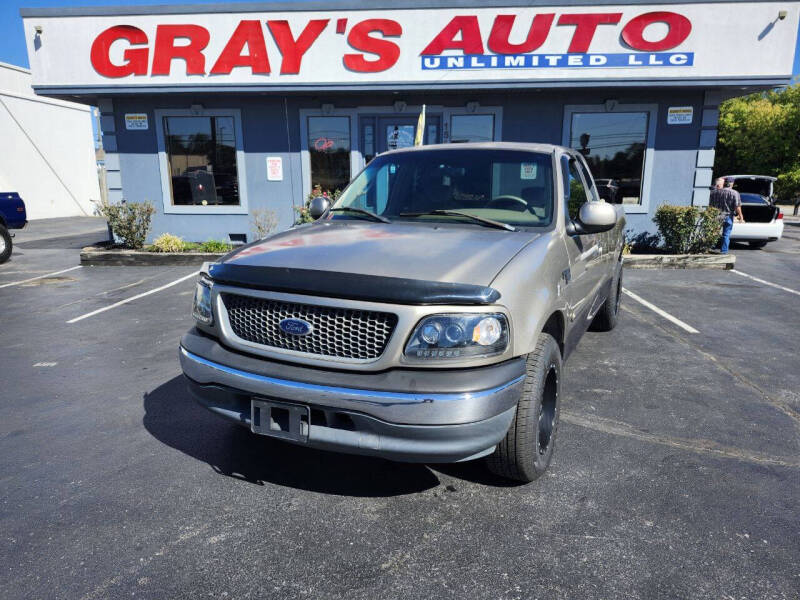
[308,117,350,192]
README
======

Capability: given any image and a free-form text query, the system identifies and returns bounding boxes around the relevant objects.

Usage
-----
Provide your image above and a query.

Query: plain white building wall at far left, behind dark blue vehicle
[0,63,100,220]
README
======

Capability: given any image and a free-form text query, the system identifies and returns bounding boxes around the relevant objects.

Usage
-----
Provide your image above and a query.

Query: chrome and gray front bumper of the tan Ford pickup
[180,346,525,462]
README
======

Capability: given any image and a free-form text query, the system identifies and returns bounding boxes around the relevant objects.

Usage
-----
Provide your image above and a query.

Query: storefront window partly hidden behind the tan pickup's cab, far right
[570,112,649,204]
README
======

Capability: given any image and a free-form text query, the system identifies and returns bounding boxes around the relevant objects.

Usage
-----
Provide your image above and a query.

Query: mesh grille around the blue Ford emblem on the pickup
[221,293,397,360]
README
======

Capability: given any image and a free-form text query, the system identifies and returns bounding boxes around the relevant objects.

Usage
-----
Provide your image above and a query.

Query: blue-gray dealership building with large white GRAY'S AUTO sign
[22,0,800,241]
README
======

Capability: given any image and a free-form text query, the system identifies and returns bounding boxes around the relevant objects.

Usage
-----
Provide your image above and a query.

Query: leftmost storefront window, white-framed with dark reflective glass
[164,116,240,206]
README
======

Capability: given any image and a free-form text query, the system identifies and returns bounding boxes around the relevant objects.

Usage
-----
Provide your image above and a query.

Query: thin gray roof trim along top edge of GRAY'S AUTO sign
[19,0,792,18]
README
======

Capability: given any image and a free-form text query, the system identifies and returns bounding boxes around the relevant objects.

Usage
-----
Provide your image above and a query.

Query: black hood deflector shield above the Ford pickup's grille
[208,263,500,305]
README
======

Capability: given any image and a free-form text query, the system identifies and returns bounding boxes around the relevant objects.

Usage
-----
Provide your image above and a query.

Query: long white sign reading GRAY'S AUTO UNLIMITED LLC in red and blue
[23,1,798,91]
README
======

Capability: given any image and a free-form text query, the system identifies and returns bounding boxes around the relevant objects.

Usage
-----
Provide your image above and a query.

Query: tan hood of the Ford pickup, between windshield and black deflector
[222,220,540,286]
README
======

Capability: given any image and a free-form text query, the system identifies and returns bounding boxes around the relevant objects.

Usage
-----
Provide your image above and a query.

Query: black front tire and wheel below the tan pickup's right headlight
[487,333,562,483]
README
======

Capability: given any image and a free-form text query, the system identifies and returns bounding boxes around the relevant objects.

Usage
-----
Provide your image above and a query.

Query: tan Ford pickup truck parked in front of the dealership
[179,143,625,482]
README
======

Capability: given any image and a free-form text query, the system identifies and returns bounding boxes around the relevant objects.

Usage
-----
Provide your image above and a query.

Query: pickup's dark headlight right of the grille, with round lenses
[405,313,508,359]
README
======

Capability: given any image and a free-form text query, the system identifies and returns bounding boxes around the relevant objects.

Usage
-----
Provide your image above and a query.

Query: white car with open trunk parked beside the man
[725,175,783,248]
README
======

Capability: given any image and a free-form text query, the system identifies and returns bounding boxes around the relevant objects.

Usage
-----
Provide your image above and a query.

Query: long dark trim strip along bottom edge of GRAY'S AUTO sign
[33,75,792,96]
